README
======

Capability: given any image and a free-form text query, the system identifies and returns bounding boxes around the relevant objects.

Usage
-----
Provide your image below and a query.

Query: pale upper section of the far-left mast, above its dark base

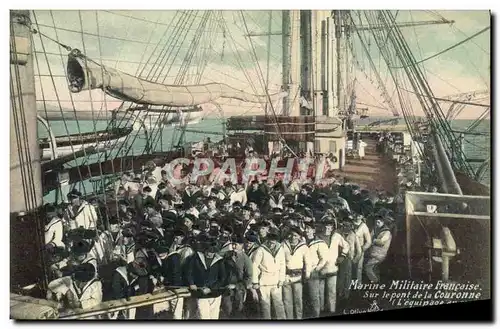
[10,10,43,213]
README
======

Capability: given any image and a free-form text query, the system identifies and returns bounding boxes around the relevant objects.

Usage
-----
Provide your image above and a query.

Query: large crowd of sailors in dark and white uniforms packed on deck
[45,133,402,319]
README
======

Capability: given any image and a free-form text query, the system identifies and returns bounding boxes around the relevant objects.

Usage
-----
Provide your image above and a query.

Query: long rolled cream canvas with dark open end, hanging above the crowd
[67,51,287,107]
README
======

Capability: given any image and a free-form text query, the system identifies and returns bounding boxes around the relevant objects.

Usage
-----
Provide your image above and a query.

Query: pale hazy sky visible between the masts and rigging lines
[32,10,490,118]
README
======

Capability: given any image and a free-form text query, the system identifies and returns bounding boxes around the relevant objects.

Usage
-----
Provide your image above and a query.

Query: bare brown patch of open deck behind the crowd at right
[336,139,397,194]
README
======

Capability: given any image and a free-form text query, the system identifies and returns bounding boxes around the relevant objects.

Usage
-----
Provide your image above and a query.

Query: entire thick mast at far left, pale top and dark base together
[10,10,47,295]
